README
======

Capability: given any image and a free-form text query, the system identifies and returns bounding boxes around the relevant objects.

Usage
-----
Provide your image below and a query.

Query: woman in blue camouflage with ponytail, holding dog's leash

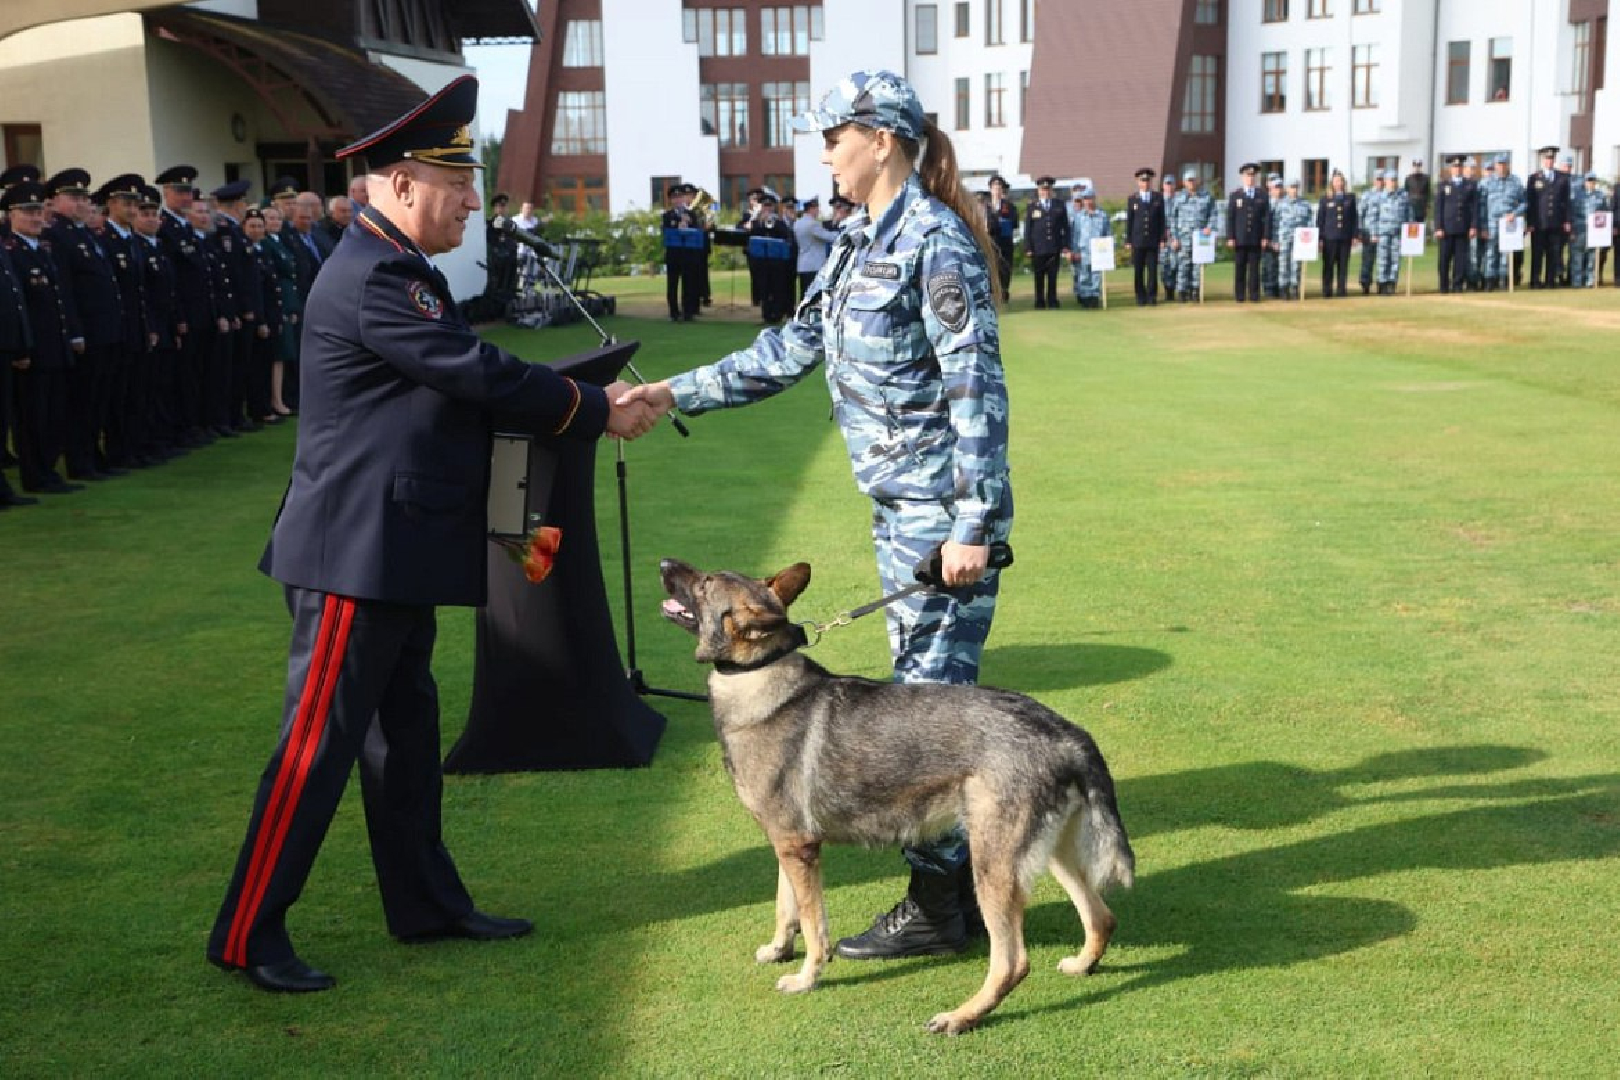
[620,71,1004,959]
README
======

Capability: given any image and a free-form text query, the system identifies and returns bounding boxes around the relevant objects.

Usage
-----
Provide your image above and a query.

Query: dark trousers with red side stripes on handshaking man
[207,586,473,967]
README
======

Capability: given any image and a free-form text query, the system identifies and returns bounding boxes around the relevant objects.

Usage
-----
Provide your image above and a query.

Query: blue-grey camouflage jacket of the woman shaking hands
[671,175,1013,544]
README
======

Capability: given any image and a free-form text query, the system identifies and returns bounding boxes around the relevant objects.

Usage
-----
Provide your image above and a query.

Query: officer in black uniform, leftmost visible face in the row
[0,180,84,494]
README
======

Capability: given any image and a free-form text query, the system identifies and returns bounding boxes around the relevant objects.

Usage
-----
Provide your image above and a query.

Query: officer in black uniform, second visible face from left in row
[44,168,126,479]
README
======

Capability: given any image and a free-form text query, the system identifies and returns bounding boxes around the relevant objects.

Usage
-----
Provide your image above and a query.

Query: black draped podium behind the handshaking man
[444,342,664,772]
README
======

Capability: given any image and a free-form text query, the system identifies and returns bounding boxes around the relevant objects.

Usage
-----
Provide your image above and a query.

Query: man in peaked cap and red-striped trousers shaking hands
[207,76,656,993]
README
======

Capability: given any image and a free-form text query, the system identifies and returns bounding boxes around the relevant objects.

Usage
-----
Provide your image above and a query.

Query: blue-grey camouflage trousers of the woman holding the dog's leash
[872,500,1013,874]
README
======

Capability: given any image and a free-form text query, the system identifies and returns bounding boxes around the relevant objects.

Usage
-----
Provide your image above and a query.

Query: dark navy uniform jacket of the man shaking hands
[259,207,608,606]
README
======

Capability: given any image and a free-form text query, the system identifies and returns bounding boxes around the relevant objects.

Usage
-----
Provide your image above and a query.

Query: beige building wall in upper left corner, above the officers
[0,15,152,183]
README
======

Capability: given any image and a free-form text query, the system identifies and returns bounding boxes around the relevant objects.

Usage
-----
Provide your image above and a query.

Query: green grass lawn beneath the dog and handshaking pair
[0,275,1620,1078]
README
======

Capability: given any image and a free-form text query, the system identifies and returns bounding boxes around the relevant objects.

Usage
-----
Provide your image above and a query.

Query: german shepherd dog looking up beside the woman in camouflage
[659,559,1136,1035]
